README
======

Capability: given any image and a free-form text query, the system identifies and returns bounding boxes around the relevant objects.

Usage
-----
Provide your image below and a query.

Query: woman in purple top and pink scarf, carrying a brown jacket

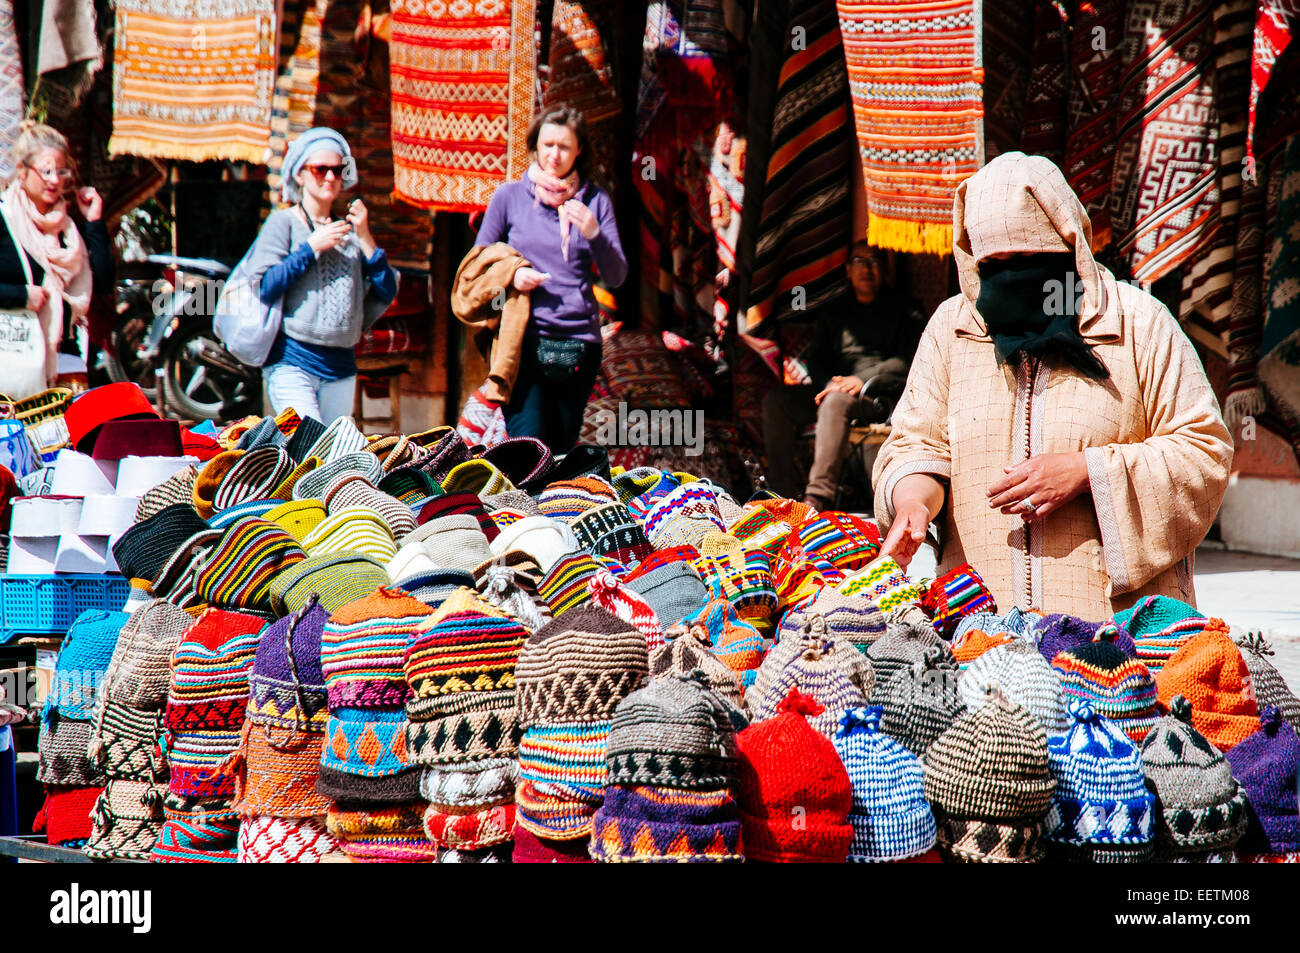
[477,105,628,454]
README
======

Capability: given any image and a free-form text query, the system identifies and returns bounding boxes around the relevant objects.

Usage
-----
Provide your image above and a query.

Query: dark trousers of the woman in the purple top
[502,338,601,455]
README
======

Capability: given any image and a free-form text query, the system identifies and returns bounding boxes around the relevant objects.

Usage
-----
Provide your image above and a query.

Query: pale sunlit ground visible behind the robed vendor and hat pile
[907,545,1300,694]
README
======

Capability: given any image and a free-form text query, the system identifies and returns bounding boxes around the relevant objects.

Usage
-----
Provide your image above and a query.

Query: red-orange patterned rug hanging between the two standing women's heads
[390,0,537,212]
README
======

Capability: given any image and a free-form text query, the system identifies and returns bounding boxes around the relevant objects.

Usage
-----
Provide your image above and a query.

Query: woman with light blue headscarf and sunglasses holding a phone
[248,129,398,424]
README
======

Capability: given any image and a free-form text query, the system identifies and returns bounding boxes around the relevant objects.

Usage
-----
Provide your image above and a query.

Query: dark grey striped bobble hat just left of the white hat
[870,640,966,758]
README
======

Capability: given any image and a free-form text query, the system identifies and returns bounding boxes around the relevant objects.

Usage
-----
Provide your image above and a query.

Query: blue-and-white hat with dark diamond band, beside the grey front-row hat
[1045,699,1156,863]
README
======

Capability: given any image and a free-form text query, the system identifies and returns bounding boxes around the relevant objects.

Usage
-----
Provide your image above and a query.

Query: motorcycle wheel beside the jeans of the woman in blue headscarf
[161,320,261,424]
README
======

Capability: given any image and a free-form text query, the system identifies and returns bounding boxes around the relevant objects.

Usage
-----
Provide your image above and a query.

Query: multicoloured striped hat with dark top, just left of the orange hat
[1052,642,1158,744]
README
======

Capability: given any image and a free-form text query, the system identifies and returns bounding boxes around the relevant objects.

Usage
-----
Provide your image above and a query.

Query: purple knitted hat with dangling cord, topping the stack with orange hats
[248,595,329,732]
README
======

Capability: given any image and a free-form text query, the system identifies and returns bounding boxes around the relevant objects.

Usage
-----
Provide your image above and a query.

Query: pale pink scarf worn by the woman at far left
[4,182,94,384]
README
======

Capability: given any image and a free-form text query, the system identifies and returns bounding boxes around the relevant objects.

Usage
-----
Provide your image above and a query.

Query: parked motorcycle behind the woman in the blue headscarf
[104,255,261,423]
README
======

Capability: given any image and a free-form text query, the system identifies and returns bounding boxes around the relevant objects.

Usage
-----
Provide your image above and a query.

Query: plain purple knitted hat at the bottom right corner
[1223,705,1300,854]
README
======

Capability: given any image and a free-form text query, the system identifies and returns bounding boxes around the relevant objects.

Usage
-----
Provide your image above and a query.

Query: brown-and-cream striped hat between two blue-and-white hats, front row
[925,676,1056,863]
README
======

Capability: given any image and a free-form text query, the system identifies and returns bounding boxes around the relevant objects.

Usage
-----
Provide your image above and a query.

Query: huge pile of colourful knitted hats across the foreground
[25,400,1300,863]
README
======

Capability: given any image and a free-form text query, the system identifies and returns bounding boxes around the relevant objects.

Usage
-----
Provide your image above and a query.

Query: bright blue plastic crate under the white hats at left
[0,573,131,644]
